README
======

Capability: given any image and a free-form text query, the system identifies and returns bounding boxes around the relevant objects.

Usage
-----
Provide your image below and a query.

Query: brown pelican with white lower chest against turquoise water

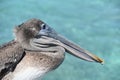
[0,19,103,80]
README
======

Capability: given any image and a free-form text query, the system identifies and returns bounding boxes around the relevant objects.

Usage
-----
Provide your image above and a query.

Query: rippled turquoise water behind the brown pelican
[0,0,120,80]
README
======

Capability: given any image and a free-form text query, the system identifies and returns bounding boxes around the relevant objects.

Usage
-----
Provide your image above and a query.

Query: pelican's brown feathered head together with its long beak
[14,19,103,63]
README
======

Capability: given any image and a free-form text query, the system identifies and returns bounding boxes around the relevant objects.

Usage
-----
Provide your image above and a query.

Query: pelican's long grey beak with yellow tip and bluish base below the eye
[34,26,103,63]
